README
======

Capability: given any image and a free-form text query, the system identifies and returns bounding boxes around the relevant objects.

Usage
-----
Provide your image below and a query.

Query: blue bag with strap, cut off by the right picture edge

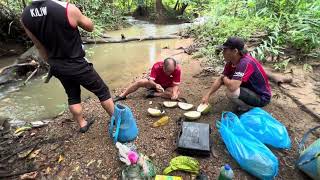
[296,126,320,180]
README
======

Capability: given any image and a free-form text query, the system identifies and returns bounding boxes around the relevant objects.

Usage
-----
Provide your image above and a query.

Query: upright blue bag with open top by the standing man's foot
[109,104,139,143]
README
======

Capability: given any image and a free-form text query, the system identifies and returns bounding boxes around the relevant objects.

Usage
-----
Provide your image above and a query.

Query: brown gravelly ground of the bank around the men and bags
[3,40,319,179]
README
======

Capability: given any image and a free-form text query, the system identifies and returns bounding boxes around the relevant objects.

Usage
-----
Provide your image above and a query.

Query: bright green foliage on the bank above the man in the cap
[188,0,320,67]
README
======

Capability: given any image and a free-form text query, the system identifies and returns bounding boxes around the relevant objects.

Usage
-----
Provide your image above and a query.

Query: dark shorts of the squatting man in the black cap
[239,87,270,107]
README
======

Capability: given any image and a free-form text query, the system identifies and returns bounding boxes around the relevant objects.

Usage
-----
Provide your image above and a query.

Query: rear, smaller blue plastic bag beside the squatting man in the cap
[240,108,291,149]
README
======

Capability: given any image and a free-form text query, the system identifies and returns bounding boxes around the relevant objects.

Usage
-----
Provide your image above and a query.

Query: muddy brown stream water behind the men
[0,18,187,121]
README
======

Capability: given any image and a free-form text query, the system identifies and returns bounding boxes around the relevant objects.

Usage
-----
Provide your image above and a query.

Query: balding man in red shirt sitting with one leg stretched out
[114,58,181,102]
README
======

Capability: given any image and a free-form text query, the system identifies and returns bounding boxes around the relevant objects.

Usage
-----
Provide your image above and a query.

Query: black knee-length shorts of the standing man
[53,65,111,105]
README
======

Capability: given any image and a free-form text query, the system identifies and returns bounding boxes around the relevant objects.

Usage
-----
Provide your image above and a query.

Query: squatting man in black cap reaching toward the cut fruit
[202,37,271,112]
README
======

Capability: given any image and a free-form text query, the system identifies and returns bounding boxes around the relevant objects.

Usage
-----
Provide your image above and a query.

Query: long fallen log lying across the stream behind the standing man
[82,36,180,44]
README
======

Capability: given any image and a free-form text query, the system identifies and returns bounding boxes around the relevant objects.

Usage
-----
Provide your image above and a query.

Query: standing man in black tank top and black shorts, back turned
[21,0,114,133]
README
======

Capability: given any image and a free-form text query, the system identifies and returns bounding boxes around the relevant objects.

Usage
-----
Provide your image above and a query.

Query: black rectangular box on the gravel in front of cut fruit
[177,120,213,156]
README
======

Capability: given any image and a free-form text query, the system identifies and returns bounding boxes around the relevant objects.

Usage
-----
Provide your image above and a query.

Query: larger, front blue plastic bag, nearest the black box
[217,112,279,179]
